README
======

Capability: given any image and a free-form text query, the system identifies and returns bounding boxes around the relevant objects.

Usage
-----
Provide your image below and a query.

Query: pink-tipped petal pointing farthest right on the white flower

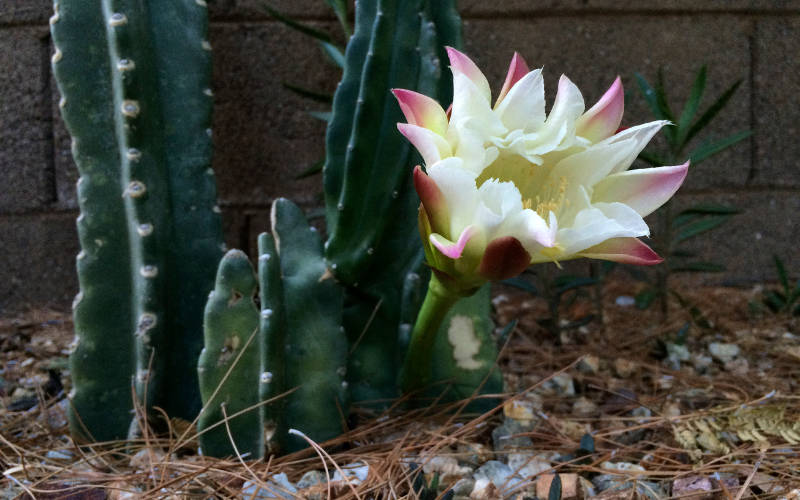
[592,161,689,217]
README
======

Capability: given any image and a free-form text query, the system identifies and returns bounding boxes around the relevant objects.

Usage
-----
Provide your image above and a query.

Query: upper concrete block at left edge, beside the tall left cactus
[0,28,55,213]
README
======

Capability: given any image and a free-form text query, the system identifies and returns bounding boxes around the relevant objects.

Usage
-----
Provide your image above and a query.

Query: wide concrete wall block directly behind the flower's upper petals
[464,15,752,190]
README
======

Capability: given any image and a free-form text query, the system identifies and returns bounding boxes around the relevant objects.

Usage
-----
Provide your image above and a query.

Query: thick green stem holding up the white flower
[399,274,470,394]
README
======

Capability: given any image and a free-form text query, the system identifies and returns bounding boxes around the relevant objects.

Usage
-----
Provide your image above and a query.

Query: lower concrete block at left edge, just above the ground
[0,212,80,315]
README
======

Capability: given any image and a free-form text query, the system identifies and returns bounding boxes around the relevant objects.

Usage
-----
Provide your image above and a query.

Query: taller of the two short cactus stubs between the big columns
[268,199,349,452]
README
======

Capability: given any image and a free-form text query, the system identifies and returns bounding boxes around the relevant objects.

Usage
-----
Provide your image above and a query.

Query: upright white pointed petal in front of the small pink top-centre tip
[496,69,545,132]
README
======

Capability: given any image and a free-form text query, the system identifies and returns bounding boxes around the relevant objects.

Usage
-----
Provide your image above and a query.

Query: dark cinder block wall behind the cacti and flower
[0,0,800,314]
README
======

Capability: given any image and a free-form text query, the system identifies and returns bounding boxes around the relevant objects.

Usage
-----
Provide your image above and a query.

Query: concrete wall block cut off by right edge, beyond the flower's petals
[753,17,800,187]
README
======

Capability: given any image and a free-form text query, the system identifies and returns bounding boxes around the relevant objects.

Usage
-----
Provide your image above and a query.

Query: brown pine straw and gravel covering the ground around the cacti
[0,277,800,500]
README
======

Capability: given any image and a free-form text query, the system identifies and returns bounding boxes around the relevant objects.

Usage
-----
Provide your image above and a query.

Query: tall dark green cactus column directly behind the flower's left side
[324,0,461,401]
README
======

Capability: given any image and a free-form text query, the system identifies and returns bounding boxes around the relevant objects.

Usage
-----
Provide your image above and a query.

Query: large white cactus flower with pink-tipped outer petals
[394,48,688,289]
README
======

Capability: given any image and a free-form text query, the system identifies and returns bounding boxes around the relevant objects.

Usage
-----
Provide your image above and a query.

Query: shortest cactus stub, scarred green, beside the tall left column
[197,250,264,459]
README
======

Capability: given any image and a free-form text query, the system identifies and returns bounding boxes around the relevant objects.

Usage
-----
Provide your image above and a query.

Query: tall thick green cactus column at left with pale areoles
[50,0,223,441]
